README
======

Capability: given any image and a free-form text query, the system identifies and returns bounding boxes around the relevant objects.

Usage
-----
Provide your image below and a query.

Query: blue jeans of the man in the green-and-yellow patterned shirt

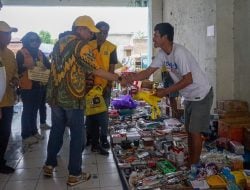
[46,106,85,175]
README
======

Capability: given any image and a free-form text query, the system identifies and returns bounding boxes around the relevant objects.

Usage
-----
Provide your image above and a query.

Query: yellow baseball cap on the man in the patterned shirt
[73,15,100,32]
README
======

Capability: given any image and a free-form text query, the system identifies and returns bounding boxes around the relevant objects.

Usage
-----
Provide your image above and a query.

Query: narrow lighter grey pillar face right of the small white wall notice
[216,0,235,100]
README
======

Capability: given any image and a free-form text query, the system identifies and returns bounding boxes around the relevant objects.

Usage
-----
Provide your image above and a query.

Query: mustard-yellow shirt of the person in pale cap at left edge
[0,48,18,107]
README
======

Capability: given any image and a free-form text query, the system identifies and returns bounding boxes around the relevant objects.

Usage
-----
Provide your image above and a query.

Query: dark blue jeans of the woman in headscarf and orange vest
[21,87,42,139]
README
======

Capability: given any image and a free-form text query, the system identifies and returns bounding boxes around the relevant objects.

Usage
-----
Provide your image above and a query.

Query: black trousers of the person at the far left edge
[0,106,13,165]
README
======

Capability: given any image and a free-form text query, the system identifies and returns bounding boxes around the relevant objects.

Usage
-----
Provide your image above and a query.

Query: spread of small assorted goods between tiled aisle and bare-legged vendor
[110,103,192,189]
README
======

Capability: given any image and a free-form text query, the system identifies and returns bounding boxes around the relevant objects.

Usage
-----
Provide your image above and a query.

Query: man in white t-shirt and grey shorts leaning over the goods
[126,23,213,165]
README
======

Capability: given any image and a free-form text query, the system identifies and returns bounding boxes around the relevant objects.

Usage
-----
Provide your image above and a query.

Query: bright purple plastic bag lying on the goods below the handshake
[111,95,137,109]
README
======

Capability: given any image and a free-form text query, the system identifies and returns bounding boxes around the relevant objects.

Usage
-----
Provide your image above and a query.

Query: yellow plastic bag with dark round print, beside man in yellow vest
[85,86,107,116]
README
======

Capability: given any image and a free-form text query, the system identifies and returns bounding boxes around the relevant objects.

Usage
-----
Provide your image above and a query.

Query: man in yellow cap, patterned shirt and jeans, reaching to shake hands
[44,15,125,186]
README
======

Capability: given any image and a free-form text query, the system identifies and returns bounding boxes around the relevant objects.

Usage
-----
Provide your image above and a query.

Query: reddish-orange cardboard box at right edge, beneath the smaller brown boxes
[218,117,250,143]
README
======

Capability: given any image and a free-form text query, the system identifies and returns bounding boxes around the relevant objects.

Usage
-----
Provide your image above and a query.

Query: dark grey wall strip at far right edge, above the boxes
[233,0,250,106]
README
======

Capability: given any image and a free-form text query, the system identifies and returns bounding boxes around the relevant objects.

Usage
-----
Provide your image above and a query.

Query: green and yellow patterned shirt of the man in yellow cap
[47,35,99,109]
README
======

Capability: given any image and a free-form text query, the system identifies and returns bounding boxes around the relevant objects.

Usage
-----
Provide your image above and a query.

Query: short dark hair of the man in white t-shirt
[154,22,174,42]
